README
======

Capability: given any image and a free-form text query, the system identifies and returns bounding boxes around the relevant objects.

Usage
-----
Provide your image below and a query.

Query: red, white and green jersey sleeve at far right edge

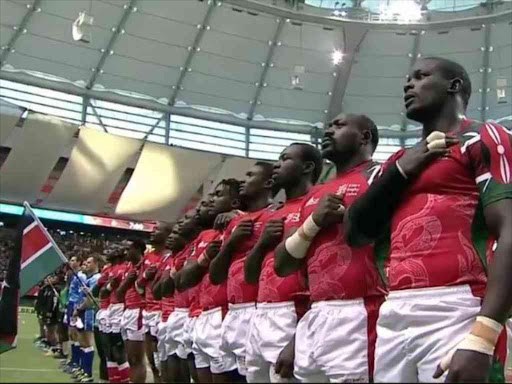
[461,123,512,207]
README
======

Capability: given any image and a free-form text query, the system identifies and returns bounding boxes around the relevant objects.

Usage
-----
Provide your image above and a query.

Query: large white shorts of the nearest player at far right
[375,285,481,383]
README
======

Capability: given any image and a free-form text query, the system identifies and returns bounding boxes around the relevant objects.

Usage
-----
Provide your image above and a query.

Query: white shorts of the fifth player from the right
[192,307,237,374]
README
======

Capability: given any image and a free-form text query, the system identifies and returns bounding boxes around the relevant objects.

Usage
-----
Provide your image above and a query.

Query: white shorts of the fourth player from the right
[220,303,256,376]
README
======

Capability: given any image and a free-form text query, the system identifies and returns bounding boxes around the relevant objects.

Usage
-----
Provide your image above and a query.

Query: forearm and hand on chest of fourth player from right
[210,220,254,285]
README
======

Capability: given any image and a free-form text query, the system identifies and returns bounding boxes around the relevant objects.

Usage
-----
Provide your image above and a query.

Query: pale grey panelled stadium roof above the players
[0,0,512,144]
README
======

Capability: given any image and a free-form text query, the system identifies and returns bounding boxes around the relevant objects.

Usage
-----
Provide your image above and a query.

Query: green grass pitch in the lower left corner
[0,313,99,383]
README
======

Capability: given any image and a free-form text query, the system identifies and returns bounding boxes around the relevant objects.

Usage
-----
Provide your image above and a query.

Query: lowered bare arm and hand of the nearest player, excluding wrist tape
[434,199,512,383]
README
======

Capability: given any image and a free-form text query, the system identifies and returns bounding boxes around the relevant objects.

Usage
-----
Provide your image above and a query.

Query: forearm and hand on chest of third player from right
[244,218,284,284]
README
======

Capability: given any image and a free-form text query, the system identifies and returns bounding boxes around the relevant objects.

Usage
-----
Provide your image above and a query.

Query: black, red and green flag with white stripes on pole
[0,202,67,353]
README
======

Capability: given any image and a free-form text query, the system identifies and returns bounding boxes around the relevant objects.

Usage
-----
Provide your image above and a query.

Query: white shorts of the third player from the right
[245,301,297,383]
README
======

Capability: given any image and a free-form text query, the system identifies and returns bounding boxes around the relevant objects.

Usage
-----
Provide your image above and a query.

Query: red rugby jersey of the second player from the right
[300,161,386,301]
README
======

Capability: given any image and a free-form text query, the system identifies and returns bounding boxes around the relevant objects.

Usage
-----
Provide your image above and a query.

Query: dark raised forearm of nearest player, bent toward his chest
[343,164,409,246]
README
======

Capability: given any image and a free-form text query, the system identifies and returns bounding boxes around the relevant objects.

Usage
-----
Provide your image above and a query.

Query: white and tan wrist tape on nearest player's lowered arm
[439,316,503,372]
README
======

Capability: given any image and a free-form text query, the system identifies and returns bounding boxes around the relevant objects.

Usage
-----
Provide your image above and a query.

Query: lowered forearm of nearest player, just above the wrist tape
[480,236,512,324]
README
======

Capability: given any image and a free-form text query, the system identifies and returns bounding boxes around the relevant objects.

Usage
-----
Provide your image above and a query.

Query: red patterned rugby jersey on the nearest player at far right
[383,120,512,296]
